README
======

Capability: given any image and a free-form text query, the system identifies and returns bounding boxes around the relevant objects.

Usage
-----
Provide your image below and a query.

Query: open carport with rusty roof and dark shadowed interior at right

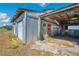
[40,4,79,37]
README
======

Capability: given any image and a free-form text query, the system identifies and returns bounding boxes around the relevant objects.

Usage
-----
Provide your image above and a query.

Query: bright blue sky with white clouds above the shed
[0,3,71,26]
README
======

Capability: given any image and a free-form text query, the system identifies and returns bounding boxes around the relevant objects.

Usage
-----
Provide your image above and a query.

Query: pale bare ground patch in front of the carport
[32,39,79,56]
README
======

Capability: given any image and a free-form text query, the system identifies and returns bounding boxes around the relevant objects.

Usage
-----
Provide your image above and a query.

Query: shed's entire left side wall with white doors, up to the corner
[13,13,26,43]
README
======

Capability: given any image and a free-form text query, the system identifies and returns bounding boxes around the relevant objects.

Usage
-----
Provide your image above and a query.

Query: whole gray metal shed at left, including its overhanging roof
[12,8,40,43]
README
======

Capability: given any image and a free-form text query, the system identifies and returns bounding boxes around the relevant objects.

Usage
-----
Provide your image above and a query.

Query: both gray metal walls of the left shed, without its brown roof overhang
[14,11,40,43]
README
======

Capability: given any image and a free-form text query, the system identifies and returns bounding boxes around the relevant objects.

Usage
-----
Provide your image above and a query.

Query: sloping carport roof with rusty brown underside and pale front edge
[40,4,79,24]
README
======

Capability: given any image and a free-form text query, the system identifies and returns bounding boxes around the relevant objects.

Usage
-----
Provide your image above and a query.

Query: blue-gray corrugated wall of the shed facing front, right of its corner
[27,17,39,41]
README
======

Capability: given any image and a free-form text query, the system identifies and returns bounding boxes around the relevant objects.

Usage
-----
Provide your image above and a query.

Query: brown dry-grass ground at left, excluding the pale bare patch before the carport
[0,31,52,56]
